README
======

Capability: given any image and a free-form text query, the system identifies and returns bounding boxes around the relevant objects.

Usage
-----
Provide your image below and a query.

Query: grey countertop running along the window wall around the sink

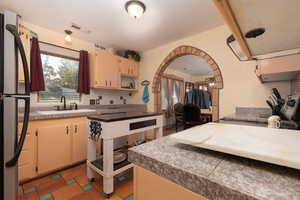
[18,104,147,121]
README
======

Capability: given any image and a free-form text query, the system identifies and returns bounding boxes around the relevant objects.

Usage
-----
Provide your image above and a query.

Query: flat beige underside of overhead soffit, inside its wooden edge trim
[229,0,300,55]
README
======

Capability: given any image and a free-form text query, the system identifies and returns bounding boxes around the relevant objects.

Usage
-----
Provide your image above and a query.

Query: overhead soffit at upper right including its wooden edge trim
[214,0,300,60]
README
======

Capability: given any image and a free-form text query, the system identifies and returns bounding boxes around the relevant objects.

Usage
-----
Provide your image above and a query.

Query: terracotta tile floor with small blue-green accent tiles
[19,164,133,200]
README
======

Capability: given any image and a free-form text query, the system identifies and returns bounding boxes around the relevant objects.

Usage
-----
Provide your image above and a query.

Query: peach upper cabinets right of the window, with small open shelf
[90,50,139,90]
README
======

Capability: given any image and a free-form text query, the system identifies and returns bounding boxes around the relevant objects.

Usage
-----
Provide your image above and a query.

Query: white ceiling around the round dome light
[0,0,223,50]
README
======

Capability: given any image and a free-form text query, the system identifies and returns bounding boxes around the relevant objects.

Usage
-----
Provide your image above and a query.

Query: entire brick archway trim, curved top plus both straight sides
[152,46,223,121]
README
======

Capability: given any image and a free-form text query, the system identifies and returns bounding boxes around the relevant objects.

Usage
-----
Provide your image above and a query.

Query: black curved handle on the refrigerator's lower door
[5,97,30,167]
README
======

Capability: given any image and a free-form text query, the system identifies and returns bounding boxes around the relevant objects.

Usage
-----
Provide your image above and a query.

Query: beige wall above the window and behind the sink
[21,21,135,106]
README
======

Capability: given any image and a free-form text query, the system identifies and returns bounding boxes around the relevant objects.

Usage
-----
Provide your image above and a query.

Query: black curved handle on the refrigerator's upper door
[6,24,30,95]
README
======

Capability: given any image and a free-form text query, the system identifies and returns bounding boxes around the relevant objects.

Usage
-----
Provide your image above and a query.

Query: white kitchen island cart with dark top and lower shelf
[87,112,163,197]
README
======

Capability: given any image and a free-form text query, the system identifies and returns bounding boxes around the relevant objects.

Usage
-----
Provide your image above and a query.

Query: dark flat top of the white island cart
[88,112,162,122]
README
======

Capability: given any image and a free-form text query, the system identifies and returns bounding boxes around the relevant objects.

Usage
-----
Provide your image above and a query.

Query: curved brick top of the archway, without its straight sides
[152,45,223,93]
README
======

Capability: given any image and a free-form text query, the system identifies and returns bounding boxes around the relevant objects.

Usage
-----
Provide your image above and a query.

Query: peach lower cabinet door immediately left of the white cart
[72,120,88,163]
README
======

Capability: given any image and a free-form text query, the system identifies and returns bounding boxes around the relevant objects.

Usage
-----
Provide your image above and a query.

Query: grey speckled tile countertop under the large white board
[129,132,300,200]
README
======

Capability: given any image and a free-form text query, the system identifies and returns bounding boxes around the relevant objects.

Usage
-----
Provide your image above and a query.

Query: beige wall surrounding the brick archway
[139,26,290,117]
